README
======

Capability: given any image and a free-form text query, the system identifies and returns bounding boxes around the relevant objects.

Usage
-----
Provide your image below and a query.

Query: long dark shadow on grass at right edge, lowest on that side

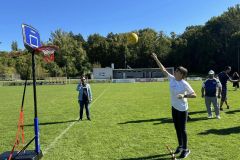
[198,126,240,135]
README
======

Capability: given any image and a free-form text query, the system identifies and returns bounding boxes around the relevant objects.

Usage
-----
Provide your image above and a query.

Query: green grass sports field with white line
[0,81,240,160]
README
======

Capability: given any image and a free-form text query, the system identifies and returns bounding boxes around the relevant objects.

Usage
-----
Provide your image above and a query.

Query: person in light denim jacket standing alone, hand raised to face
[77,76,92,121]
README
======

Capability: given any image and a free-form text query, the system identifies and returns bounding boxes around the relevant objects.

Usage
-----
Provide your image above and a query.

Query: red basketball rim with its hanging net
[34,45,59,62]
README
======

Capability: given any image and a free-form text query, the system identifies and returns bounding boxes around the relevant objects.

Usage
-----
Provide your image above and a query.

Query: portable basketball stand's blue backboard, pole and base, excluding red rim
[0,24,43,160]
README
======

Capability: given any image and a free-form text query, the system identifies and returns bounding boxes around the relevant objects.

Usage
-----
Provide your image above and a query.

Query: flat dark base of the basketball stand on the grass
[0,150,43,160]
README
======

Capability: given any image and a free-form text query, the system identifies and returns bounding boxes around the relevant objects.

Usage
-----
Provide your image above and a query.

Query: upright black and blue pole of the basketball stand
[31,51,41,154]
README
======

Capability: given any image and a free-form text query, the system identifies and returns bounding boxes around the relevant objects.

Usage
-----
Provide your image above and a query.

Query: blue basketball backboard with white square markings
[22,24,41,51]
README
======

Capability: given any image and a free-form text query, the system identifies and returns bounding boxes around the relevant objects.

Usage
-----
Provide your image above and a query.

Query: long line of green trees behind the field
[0,5,240,78]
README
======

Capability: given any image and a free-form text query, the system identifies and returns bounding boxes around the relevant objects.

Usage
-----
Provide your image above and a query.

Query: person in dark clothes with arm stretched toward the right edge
[218,66,239,111]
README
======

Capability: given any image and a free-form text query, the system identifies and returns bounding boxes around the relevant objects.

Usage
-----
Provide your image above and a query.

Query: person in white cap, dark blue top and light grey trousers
[201,70,222,119]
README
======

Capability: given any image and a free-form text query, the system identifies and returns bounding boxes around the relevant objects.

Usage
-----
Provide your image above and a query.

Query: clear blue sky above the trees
[0,0,240,51]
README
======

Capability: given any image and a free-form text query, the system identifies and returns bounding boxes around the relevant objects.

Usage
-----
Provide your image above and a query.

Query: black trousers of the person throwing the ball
[172,107,188,149]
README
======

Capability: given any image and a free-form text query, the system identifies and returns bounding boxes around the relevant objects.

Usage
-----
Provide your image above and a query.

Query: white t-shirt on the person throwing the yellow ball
[168,74,194,111]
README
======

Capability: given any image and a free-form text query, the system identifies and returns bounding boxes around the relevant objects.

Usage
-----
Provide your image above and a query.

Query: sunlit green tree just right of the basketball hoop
[50,30,90,77]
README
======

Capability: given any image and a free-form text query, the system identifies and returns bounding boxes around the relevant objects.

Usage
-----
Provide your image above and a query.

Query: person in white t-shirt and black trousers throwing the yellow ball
[152,53,196,158]
